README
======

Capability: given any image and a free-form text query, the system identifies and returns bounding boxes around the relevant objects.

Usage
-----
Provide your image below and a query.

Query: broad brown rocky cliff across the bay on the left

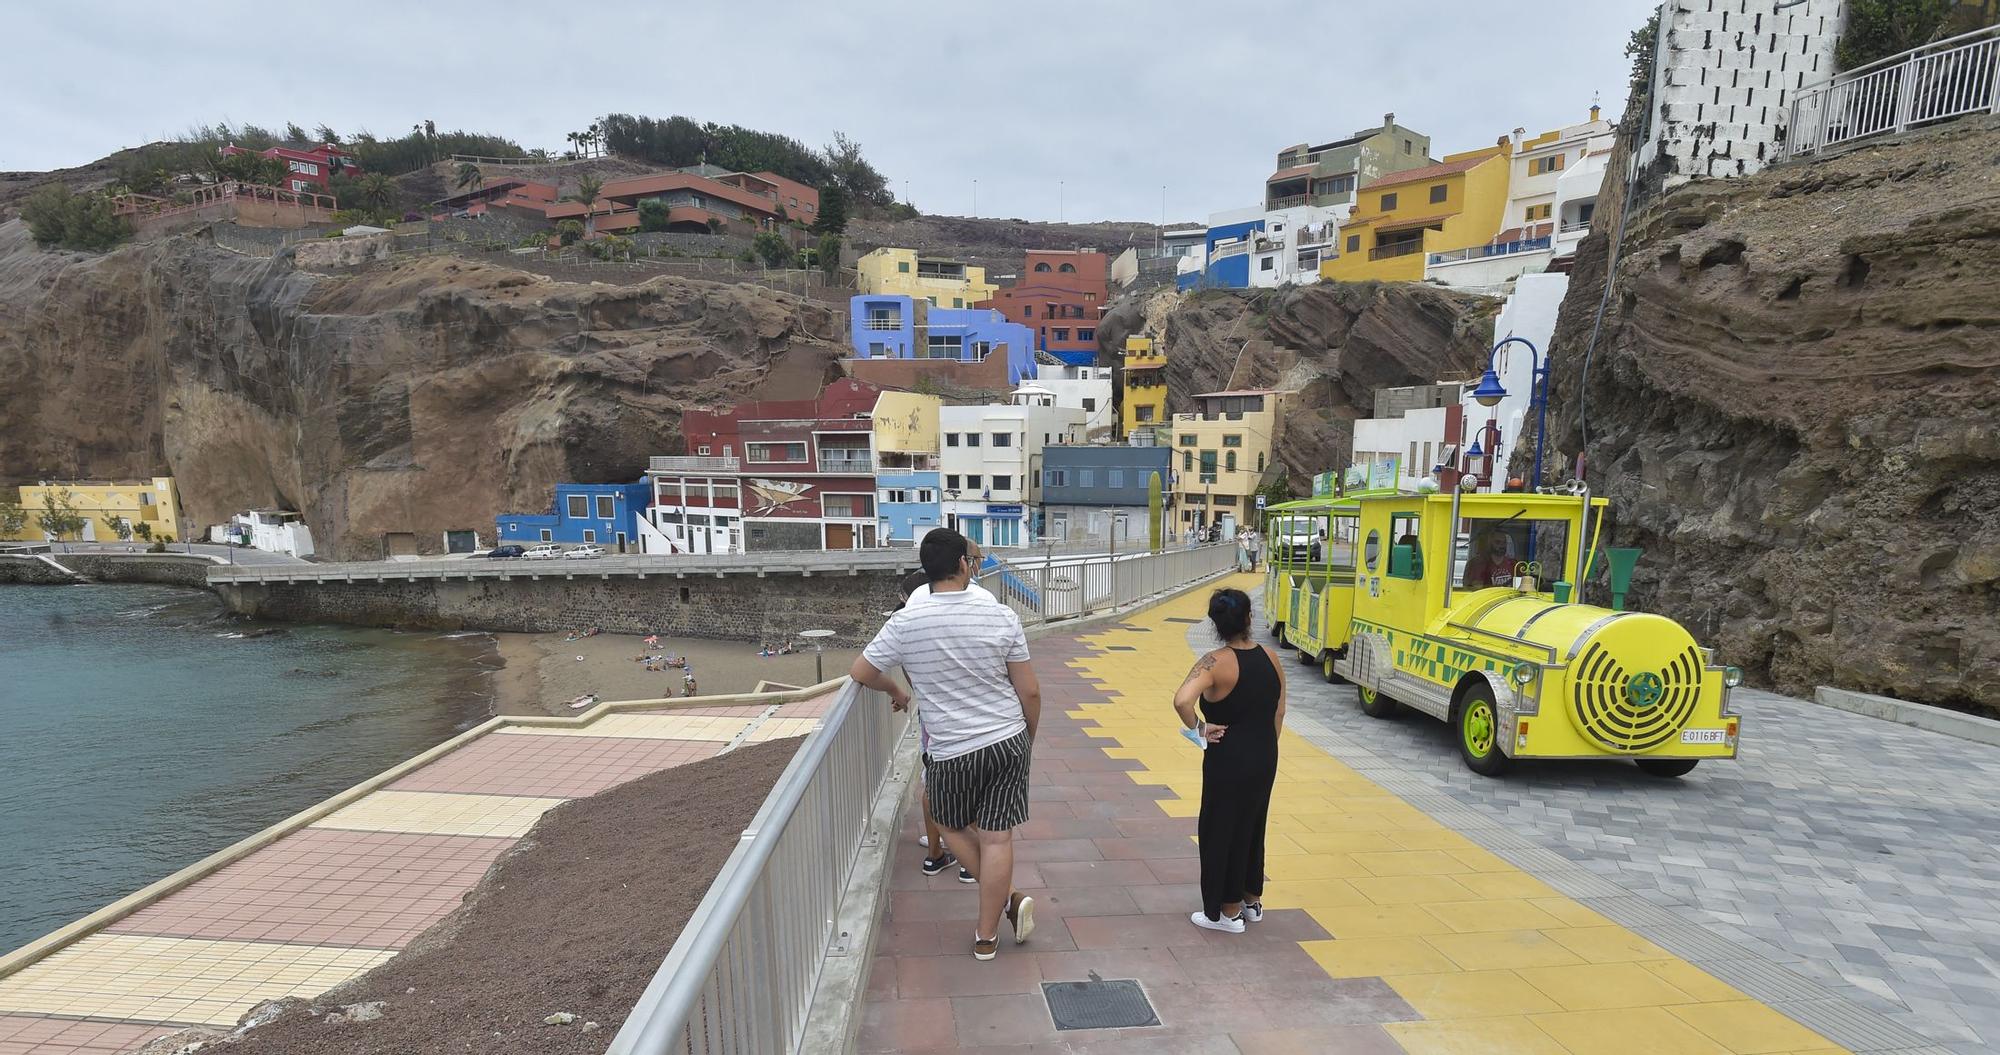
[0,220,844,557]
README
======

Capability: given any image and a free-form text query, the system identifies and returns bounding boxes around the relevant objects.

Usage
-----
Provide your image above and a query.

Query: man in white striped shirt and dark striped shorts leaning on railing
[850,528,1042,959]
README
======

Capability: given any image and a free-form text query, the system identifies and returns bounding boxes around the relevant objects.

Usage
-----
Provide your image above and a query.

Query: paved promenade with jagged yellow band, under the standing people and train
[860,577,2000,1055]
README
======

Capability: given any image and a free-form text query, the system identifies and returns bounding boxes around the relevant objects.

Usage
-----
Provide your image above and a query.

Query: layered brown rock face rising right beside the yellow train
[1550,120,2000,709]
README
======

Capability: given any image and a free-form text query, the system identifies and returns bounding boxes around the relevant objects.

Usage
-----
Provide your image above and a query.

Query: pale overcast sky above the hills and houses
[0,0,1654,220]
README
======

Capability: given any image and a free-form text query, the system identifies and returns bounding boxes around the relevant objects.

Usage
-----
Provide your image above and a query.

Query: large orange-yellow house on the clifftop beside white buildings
[1320,138,1510,282]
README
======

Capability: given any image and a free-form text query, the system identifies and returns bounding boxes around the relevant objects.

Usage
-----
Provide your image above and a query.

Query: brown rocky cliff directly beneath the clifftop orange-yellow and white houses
[1144,282,1500,494]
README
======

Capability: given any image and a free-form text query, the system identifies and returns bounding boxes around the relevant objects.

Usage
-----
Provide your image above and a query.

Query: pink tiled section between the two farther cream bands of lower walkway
[390,733,724,799]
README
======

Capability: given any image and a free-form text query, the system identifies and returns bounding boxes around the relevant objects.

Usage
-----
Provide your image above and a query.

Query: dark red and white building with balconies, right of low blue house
[646,378,882,553]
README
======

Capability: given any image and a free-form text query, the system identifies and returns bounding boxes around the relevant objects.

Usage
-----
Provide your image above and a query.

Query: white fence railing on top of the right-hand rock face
[1784,26,2000,158]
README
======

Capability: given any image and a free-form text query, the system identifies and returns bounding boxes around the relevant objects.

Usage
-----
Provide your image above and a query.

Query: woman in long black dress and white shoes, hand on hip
[1174,589,1284,933]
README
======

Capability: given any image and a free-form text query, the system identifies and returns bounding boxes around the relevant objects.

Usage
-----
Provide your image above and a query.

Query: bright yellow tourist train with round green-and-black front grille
[1264,481,1742,777]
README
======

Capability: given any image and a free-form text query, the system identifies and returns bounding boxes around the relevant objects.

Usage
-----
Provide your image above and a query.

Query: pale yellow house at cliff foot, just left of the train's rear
[1172,388,1284,531]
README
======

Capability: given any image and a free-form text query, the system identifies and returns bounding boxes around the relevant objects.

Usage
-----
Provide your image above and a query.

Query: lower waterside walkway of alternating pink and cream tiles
[0,697,828,1055]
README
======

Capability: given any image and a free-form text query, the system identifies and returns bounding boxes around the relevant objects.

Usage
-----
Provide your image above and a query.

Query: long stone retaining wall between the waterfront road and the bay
[212,569,904,645]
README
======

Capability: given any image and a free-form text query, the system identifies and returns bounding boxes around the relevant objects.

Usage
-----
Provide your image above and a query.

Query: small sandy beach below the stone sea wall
[492,633,858,715]
